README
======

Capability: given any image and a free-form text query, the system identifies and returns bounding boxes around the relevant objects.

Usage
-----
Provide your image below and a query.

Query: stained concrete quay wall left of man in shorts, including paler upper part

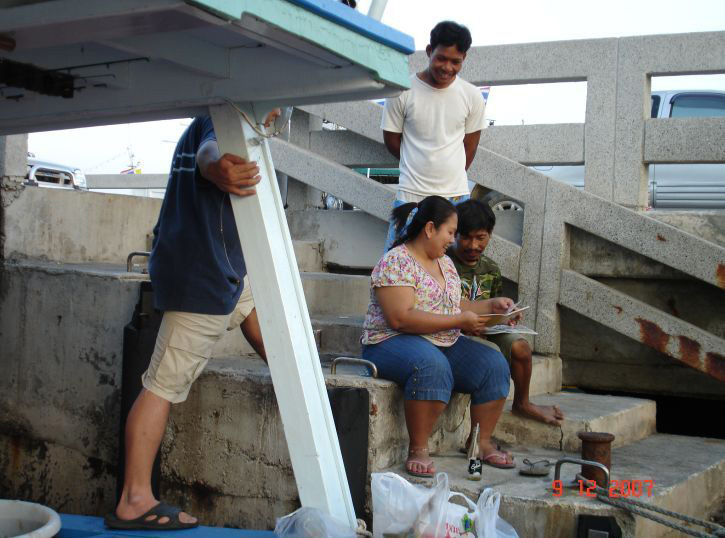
[0,166,159,515]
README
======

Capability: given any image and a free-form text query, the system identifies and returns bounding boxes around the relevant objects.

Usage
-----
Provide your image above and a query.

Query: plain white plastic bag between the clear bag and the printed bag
[371,473,449,538]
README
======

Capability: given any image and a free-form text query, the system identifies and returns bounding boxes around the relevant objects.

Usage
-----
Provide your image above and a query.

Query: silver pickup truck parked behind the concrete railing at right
[473,90,725,211]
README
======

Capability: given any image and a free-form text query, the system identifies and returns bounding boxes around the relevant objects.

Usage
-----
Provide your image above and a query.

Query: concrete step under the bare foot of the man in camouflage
[494,392,656,451]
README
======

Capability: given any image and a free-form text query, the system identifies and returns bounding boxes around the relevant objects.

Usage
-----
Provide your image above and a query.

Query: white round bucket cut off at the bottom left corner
[0,499,60,538]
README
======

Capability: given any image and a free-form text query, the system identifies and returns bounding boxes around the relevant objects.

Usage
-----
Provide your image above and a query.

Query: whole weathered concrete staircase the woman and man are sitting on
[163,230,725,537]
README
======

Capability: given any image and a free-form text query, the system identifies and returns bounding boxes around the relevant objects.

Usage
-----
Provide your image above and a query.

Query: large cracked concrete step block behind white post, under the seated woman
[161,357,468,528]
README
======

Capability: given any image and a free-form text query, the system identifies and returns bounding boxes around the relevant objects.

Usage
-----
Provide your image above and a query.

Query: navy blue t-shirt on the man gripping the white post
[149,116,247,315]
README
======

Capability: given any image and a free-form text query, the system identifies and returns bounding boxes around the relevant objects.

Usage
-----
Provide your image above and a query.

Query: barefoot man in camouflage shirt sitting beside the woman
[448,200,564,425]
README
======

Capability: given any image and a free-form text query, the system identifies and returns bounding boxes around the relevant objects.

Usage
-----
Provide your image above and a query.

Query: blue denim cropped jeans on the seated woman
[362,334,511,405]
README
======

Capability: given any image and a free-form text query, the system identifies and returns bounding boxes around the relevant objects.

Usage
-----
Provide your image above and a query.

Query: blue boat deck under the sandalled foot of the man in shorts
[56,514,275,538]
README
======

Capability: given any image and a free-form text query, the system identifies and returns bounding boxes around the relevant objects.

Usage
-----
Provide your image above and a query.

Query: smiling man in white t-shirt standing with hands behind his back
[381,21,486,250]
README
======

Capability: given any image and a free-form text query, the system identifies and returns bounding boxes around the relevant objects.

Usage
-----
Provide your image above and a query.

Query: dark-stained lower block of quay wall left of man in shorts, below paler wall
[0,263,139,515]
